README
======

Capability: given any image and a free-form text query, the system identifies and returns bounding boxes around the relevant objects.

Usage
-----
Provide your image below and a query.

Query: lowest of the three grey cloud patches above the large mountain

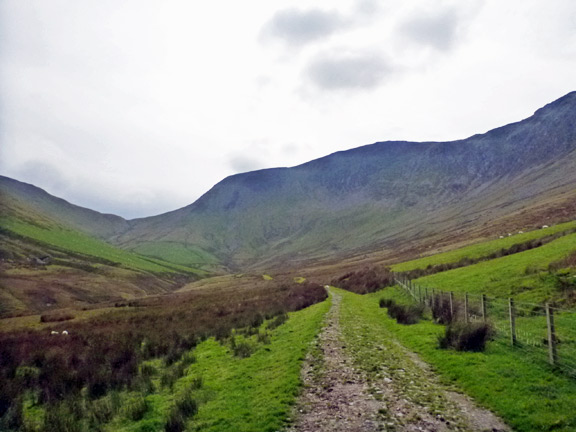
[305,53,393,90]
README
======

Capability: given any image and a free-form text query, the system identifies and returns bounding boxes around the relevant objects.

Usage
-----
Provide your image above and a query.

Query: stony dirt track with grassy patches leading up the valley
[288,292,510,432]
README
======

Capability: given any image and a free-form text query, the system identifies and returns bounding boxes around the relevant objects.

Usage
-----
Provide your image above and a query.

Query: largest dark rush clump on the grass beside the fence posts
[438,322,494,352]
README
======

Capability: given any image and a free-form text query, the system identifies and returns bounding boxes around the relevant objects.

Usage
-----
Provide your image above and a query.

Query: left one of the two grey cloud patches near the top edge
[261,8,346,46]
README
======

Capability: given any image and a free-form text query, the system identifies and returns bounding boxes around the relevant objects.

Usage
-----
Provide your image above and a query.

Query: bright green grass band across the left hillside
[1,218,205,273]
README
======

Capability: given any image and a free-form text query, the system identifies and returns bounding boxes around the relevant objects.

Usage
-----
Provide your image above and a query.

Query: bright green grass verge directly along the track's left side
[109,300,330,432]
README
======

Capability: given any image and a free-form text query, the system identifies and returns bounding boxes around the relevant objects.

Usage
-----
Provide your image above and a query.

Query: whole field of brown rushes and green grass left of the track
[0,281,328,431]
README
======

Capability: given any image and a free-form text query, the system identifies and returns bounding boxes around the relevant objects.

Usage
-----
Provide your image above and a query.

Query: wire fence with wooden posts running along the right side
[395,275,576,376]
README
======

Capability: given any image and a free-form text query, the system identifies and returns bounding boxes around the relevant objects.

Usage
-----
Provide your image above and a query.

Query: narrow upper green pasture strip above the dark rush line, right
[392,221,576,272]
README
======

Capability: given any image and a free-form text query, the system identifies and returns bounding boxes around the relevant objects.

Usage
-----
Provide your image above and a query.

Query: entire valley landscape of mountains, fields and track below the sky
[0,92,576,432]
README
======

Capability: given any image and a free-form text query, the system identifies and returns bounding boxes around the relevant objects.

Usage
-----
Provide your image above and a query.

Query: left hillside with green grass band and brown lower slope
[0,177,206,317]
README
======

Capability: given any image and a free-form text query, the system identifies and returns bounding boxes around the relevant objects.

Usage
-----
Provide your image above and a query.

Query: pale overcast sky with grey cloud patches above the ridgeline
[0,0,576,218]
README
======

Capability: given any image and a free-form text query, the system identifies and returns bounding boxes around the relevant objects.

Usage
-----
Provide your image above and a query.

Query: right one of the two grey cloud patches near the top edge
[400,9,459,51]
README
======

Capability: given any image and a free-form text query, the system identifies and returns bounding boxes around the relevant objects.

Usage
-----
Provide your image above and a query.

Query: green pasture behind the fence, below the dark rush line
[418,234,576,302]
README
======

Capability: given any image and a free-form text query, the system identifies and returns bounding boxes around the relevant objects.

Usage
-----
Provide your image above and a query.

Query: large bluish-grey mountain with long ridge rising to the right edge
[115,92,576,270]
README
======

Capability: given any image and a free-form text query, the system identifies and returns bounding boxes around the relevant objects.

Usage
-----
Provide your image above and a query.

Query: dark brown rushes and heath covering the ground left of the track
[0,283,326,431]
